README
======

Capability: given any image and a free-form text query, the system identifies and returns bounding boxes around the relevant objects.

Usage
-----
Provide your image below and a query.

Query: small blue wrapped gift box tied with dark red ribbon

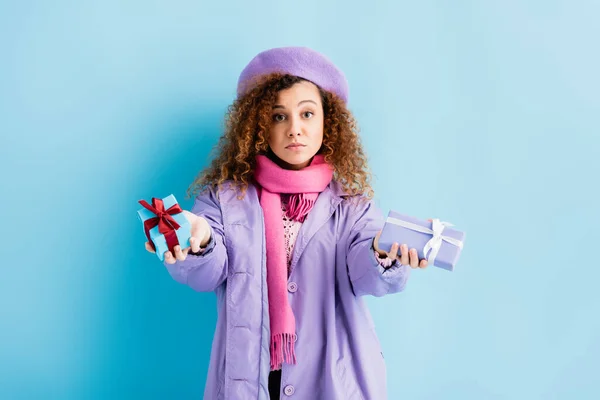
[138,195,191,261]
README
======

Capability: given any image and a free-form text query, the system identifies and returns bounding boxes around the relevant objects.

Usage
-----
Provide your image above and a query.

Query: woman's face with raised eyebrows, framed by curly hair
[268,81,324,169]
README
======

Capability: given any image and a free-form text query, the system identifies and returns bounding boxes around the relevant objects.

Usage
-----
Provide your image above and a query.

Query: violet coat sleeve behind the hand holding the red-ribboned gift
[164,189,227,292]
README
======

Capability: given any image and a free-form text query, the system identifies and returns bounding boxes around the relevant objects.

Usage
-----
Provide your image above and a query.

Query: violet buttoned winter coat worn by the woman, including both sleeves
[165,181,410,400]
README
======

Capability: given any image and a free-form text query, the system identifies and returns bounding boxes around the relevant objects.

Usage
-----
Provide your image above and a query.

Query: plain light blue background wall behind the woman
[0,0,600,400]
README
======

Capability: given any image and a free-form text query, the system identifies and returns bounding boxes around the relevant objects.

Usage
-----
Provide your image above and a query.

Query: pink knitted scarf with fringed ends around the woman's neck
[254,155,333,370]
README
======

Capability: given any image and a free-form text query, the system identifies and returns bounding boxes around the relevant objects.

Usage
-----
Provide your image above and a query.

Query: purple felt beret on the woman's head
[237,47,348,103]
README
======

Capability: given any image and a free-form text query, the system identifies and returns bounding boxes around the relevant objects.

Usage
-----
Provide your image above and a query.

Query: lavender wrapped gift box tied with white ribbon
[379,211,465,271]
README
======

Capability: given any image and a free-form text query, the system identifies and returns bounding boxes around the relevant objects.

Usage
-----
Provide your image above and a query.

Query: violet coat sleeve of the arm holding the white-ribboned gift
[346,201,410,297]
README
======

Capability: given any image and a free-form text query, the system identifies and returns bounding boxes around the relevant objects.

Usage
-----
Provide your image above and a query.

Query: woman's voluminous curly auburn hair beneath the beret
[187,73,373,199]
